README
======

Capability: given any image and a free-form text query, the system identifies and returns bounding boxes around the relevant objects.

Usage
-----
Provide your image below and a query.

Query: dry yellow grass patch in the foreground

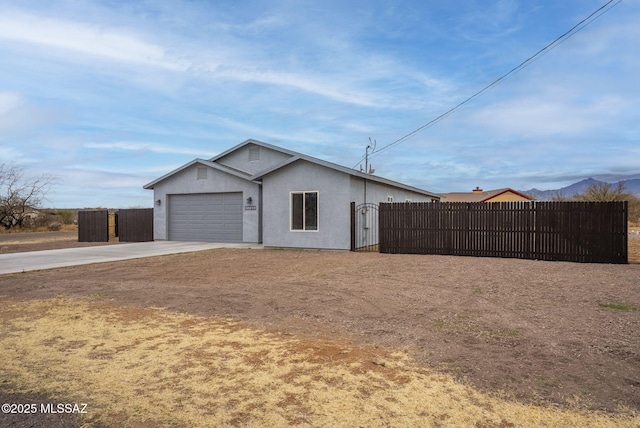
[0,298,640,427]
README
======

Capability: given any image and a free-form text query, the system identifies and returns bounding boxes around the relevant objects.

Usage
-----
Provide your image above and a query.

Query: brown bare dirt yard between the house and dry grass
[0,234,640,413]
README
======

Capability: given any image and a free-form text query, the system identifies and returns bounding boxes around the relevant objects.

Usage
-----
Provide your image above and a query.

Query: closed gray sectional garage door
[169,192,242,242]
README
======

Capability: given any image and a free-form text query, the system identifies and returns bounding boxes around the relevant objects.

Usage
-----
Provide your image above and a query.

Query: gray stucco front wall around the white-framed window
[262,160,351,249]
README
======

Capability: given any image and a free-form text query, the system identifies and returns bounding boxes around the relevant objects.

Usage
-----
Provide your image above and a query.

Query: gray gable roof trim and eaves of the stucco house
[143,139,440,199]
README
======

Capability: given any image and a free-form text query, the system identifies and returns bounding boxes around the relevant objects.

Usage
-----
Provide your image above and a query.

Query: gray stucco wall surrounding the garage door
[153,163,261,243]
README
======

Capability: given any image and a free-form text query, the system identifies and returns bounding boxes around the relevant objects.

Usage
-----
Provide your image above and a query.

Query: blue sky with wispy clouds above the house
[0,0,640,208]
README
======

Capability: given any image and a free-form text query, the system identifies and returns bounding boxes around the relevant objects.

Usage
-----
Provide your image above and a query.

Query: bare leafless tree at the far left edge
[0,163,54,230]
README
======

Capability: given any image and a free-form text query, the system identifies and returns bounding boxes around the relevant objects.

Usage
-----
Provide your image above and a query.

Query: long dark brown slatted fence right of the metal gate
[379,202,628,263]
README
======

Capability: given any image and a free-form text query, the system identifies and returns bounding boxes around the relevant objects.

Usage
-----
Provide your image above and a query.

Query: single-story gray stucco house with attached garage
[144,140,440,249]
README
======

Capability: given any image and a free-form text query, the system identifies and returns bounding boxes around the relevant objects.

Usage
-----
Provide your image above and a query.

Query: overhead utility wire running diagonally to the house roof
[353,0,622,168]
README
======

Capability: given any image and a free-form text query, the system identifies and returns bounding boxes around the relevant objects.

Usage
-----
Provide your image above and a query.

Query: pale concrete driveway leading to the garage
[0,241,262,274]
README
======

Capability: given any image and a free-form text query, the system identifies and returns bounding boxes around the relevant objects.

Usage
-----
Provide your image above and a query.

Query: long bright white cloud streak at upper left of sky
[0,10,442,108]
